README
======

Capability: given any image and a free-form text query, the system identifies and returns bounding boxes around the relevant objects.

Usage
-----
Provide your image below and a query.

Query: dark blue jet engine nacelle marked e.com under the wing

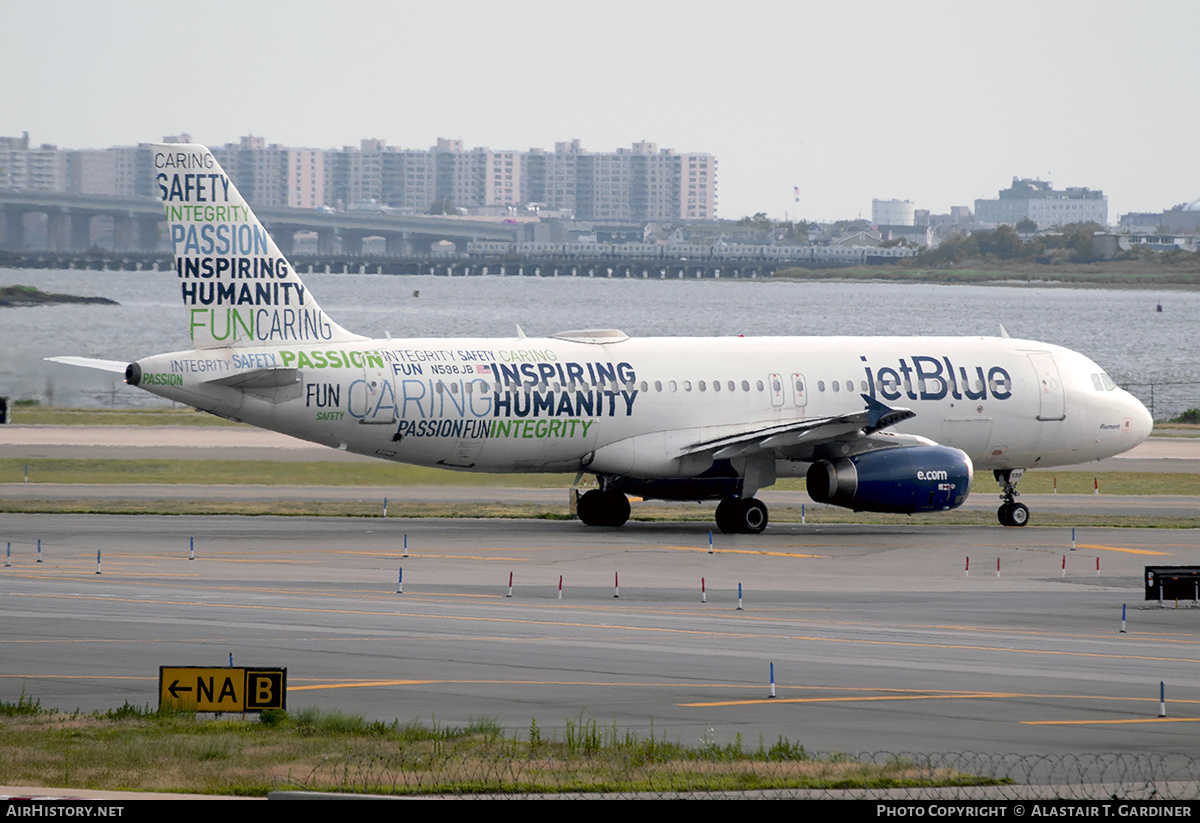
[808,445,974,515]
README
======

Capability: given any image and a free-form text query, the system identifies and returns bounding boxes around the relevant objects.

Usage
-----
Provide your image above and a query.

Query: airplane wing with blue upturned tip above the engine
[683,395,917,459]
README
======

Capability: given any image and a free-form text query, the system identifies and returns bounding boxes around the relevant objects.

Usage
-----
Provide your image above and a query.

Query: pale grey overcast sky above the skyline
[0,0,1200,222]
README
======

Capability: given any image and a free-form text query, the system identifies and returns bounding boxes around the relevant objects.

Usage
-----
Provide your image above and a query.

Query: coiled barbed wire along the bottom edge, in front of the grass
[285,747,1200,801]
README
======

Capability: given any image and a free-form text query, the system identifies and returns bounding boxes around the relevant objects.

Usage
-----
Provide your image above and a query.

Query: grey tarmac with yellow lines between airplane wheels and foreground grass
[0,515,1200,753]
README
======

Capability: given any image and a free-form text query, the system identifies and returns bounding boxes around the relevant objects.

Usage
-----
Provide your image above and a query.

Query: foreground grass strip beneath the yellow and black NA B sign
[0,696,1009,797]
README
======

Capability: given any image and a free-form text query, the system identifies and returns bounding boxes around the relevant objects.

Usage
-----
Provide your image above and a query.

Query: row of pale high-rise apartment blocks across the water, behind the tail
[0,133,716,222]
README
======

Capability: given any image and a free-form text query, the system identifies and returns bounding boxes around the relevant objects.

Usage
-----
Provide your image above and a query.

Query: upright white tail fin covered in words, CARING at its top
[152,143,364,348]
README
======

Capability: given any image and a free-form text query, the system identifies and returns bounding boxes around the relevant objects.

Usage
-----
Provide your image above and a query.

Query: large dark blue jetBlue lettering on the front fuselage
[859,354,1013,401]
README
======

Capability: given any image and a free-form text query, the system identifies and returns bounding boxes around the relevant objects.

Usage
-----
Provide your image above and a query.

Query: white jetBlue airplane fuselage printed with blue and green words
[138,337,1151,479]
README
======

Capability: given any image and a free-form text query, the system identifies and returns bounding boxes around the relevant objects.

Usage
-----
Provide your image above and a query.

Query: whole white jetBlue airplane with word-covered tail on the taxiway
[53,144,1152,534]
